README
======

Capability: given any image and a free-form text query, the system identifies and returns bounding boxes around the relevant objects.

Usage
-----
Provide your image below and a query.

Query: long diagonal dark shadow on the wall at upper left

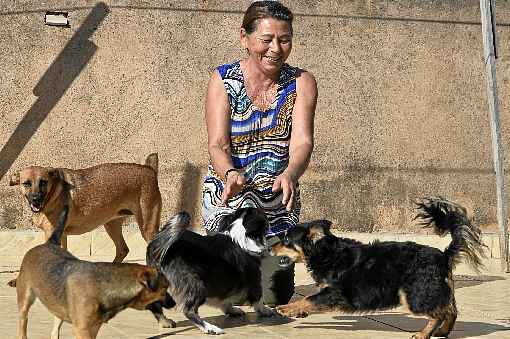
[0,2,109,179]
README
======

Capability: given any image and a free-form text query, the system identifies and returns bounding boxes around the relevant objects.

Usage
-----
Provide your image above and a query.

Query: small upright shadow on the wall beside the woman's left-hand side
[177,162,202,228]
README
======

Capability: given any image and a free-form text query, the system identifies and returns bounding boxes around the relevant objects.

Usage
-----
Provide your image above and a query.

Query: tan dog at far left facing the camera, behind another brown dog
[10,153,161,262]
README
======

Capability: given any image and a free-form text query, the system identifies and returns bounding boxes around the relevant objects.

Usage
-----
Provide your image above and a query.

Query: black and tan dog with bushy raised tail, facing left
[272,197,484,339]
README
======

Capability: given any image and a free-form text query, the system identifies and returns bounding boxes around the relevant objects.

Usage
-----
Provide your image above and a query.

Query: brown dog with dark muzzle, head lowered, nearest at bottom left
[9,206,171,339]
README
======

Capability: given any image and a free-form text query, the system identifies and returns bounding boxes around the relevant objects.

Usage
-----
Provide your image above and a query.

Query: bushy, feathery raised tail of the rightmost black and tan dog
[416,197,487,272]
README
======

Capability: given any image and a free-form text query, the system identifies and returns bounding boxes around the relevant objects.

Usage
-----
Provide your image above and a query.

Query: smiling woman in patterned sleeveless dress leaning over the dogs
[202,1,317,305]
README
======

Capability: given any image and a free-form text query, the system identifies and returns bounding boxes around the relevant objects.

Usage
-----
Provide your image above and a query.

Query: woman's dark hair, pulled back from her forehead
[241,1,294,34]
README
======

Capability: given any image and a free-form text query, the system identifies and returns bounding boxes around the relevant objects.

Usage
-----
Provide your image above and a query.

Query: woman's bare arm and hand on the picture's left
[205,70,246,204]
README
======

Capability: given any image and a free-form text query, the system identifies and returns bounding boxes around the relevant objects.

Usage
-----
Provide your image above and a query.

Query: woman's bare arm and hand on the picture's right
[273,71,318,211]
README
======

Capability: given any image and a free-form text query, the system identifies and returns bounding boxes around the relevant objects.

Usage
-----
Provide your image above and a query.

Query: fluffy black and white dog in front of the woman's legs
[147,208,277,334]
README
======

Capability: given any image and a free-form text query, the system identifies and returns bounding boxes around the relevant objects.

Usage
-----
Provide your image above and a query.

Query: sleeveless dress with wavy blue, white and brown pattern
[202,61,301,236]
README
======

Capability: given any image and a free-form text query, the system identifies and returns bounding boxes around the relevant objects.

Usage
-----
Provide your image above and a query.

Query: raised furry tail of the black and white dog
[146,211,191,268]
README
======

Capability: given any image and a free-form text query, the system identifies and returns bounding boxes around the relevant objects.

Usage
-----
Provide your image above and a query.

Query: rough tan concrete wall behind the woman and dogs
[0,0,510,232]
